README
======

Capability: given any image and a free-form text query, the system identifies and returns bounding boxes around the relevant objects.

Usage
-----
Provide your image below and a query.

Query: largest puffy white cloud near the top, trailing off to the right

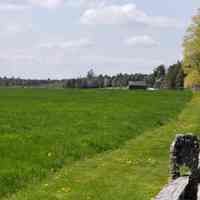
[81,4,182,28]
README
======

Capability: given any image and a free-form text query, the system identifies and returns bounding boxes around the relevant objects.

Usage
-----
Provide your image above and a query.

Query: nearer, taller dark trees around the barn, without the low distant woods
[64,61,185,89]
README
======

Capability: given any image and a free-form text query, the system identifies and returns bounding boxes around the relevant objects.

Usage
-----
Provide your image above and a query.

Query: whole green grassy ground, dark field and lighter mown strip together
[0,89,191,200]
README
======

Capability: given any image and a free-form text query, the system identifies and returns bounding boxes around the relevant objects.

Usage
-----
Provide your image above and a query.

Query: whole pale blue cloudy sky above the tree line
[0,0,200,79]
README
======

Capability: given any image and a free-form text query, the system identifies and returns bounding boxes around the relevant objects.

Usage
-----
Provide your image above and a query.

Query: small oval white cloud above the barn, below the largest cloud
[124,35,159,47]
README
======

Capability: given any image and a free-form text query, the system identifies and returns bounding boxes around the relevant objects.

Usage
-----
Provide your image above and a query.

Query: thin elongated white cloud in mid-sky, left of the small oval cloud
[39,38,93,49]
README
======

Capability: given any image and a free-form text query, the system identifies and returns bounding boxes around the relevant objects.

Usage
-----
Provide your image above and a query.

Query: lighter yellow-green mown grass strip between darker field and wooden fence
[4,95,200,200]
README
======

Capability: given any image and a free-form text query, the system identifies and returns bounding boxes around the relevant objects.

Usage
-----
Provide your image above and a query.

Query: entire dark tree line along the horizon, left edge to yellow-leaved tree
[0,61,184,89]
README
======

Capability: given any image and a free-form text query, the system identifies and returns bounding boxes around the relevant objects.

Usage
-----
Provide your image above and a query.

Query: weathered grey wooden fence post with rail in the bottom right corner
[155,134,200,200]
